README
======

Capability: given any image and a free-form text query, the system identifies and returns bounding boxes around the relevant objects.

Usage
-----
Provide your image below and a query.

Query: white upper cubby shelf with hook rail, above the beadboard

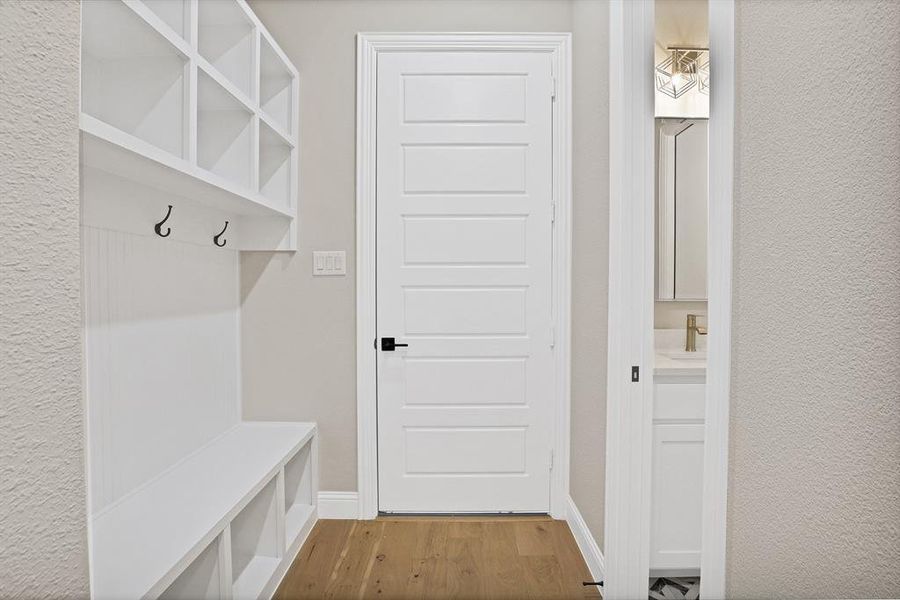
[81,0,299,250]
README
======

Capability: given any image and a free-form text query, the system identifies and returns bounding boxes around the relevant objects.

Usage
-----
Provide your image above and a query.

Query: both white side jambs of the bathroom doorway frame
[604,0,734,600]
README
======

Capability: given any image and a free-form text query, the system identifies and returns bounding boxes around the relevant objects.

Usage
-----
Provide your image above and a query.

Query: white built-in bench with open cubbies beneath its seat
[91,422,318,599]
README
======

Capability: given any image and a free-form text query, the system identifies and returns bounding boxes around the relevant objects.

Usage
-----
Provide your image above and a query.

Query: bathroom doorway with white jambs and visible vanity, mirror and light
[604,0,734,598]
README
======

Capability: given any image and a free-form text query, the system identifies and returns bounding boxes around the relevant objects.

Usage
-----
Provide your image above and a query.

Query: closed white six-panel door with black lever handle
[376,52,554,512]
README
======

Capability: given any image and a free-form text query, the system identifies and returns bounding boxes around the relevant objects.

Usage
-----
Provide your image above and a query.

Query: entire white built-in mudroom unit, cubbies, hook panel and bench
[80,0,318,600]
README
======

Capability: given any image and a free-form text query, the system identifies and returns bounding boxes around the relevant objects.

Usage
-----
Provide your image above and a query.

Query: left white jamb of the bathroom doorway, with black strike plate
[603,0,655,599]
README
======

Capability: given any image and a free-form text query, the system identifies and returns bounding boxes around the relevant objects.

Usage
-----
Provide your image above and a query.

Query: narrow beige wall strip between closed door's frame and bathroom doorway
[569,0,609,549]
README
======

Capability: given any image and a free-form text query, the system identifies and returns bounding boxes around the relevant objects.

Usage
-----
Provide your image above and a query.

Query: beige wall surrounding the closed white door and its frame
[241,0,609,539]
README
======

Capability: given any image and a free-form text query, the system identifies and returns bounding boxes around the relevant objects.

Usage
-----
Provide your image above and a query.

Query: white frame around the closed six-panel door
[356,33,572,519]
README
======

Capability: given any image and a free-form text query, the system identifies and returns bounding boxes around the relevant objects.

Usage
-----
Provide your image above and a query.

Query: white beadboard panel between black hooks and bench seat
[82,227,240,514]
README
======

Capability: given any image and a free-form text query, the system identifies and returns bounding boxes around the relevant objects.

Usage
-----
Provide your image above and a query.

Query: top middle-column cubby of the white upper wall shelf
[198,0,256,99]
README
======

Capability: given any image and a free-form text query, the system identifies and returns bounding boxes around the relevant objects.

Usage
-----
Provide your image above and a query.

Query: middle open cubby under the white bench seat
[231,479,282,599]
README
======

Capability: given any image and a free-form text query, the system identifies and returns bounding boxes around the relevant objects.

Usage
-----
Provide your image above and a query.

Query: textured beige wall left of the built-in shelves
[0,0,89,598]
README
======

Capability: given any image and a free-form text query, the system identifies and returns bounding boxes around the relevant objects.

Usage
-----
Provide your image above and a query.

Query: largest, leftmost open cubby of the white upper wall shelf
[81,0,188,158]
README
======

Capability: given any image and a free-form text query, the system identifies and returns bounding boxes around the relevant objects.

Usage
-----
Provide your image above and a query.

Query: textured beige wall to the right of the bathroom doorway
[727,0,900,598]
